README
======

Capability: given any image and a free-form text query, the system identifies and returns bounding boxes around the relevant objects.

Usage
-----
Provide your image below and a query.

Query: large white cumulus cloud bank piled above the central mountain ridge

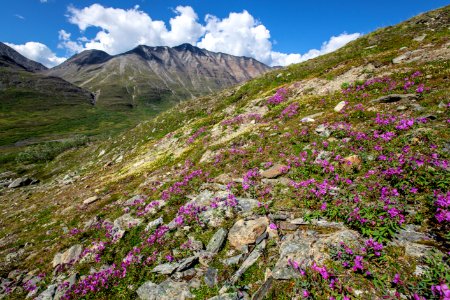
[59,4,360,66]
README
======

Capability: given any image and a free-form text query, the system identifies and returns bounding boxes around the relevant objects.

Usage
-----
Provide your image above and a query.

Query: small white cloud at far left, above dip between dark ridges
[5,42,66,67]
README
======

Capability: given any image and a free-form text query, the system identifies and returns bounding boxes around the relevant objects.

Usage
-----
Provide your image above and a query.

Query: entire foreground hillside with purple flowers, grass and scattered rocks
[0,6,450,300]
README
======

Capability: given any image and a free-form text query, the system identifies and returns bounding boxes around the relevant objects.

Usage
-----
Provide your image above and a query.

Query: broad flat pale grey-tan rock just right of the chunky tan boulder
[272,229,362,279]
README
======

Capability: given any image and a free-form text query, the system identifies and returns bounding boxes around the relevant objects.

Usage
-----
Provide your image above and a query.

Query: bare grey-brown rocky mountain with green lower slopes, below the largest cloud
[43,44,270,110]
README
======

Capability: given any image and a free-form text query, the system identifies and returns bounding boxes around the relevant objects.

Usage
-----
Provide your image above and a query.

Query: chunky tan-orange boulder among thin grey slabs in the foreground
[228,217,269,249]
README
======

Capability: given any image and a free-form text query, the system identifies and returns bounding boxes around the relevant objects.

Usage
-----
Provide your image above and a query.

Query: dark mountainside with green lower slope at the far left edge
[0,43,95,148]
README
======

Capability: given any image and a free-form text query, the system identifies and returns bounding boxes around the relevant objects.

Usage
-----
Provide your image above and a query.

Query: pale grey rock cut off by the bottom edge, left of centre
[136,279,194,300]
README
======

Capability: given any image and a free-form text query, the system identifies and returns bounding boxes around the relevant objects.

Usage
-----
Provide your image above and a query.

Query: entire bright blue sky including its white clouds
[0,0,449,66]
